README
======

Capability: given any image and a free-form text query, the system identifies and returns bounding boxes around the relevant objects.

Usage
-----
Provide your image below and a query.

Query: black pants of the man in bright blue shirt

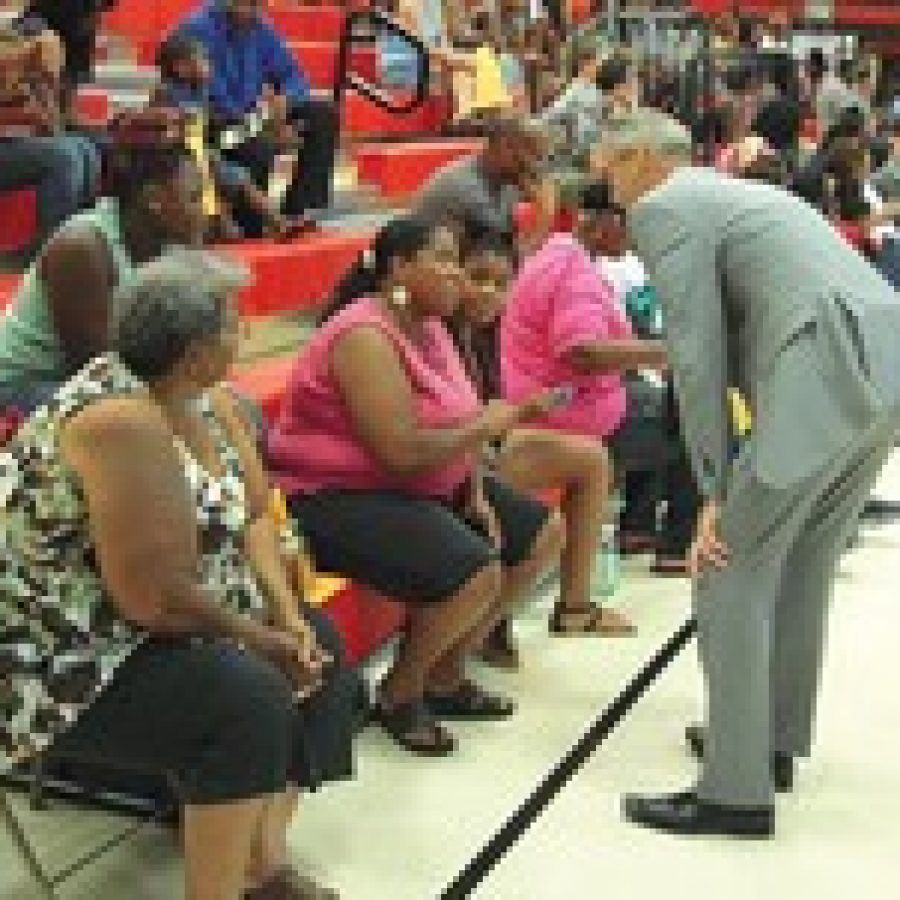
[223,98,339,236]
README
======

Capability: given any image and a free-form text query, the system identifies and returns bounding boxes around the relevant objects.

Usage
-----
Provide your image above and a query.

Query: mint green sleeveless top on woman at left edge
[0,197,135,397]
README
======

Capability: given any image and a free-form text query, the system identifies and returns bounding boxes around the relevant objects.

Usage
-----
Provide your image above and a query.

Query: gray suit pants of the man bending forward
[695,417,897,807]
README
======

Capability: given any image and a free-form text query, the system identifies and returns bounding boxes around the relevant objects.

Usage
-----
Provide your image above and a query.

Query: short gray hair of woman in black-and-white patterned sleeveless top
[110,248,250,381]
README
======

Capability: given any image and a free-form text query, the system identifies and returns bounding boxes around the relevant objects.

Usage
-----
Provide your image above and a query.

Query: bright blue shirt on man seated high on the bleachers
[177,0,309,119]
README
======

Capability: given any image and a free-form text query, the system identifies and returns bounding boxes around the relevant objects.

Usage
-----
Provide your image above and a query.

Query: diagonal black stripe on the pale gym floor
[440,618,697,900]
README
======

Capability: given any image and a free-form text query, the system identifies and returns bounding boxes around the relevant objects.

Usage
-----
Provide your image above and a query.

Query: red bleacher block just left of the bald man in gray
[353,140,481,197]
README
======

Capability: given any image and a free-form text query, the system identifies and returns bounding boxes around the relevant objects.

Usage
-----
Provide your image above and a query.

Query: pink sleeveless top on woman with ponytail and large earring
[268,299,480,500]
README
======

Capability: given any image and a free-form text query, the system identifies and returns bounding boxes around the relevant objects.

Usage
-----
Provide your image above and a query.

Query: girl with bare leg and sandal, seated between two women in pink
[451,224,634,667]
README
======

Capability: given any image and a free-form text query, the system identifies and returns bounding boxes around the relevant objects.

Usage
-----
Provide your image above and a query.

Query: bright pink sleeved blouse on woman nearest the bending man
[500,235,631,437]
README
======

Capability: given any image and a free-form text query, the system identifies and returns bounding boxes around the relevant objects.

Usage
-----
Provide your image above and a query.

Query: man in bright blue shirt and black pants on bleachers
[176,0,338,215]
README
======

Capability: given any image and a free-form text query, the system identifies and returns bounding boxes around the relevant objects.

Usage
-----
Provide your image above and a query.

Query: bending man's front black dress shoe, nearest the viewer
[623,791,775,838]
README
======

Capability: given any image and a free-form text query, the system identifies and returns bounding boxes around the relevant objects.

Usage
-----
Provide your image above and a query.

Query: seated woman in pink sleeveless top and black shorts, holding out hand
[267,218,561,755]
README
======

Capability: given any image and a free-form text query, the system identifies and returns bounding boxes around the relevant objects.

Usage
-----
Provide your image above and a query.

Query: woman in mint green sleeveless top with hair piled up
[0,111,205,413]
